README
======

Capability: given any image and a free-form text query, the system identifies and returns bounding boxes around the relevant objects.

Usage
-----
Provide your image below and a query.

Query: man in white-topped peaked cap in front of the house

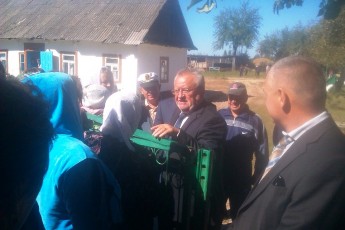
[138,72,160,133]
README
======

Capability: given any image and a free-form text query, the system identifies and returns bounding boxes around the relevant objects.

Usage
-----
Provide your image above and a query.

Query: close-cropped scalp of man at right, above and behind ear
[267,56,326,111]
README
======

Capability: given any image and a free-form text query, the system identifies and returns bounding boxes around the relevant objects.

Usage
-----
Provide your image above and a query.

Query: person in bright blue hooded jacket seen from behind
[23,72,121,229]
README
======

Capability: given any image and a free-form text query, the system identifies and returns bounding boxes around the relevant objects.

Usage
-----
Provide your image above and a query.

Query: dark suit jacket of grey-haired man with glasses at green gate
[173,102,227,230]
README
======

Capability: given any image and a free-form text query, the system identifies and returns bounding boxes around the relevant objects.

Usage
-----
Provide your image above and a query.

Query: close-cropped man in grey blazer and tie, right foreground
[233,56,345,230]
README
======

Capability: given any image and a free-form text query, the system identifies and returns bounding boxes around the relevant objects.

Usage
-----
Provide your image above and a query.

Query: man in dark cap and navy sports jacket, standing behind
[218,82,268,223]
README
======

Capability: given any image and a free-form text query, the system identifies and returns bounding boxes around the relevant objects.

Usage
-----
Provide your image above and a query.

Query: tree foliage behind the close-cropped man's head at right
[257,8,345,70]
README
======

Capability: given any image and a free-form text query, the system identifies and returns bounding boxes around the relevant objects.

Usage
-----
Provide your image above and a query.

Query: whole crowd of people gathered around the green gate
[0,56,345,230]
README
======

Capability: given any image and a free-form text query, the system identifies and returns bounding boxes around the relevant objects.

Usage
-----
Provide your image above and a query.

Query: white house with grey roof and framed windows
[0,0,196,90]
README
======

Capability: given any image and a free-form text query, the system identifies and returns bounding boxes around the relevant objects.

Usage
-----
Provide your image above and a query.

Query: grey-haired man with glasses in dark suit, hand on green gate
[152,69,226,229]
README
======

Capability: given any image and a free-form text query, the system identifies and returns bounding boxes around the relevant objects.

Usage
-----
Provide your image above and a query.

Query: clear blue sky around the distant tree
[179,0,321,57]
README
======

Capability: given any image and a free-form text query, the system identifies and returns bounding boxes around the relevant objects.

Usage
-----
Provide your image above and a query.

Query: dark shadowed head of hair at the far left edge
[0,80,54,228]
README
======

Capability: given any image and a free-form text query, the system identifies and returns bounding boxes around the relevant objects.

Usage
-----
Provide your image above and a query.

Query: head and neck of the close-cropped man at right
[264,56,326,132]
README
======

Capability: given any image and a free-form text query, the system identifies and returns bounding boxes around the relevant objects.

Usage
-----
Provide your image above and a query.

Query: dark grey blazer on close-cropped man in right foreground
[234,118,345,230]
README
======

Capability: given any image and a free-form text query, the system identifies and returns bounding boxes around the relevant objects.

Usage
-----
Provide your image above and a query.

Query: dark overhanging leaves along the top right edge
[273,0,345,19]
